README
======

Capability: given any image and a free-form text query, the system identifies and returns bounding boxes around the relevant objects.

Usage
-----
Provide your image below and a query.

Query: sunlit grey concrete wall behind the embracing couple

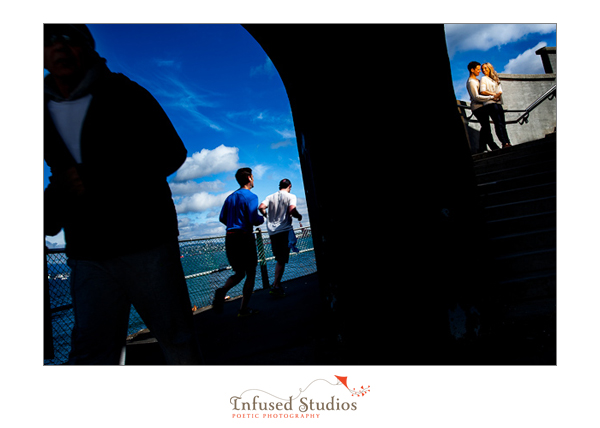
[461,47,557,152]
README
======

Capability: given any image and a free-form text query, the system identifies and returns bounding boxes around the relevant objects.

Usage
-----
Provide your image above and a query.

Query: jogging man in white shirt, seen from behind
[258,178,302,297]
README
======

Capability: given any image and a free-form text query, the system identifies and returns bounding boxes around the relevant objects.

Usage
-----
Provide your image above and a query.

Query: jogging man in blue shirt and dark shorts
[213,168,265,318]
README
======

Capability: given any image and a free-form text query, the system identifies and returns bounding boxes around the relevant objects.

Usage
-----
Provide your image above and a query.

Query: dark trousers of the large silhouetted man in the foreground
[68,240,202,364]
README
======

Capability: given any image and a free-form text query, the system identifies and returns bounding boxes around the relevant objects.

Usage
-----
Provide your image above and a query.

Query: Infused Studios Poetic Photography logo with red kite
[229,376,371,419]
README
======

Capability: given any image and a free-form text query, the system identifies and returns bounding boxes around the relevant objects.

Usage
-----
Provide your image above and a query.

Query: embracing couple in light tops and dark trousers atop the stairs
[467,61,511,153]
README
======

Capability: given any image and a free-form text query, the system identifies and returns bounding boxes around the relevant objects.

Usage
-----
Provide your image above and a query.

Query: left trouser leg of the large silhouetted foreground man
[68,259,131,365]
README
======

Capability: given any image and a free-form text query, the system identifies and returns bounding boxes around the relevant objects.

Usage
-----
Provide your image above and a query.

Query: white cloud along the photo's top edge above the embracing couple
[444,24,556,58]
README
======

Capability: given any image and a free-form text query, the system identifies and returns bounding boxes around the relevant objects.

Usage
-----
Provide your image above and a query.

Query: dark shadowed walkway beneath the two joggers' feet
[125,274,323,365]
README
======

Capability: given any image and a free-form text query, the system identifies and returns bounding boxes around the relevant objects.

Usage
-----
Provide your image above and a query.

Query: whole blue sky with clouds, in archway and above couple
[44,24,556,246]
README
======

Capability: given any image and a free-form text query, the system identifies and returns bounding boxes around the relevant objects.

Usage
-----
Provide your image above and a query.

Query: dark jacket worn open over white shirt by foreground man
[44,61,187,260]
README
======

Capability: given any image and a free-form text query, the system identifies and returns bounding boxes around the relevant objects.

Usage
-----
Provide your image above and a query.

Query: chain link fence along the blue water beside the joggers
[44,227,317,365]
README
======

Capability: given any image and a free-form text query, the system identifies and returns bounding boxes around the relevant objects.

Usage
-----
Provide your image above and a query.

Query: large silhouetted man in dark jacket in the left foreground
[44,25,202,364]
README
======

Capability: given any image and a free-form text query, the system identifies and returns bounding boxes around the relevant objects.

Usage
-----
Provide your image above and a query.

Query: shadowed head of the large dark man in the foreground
[44,24,98,89]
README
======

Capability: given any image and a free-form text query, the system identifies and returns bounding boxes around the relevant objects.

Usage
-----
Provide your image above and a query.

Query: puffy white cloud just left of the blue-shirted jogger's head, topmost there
[174,144,239,181]
